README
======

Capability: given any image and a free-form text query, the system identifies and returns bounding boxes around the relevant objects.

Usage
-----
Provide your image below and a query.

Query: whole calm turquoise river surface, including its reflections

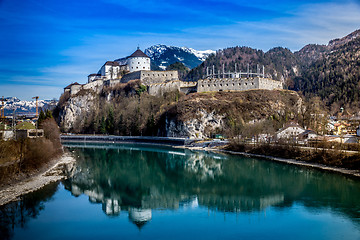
[0,144,360,239]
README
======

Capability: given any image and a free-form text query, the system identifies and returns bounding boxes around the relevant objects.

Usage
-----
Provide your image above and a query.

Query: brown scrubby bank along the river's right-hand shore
[226,142,360,170]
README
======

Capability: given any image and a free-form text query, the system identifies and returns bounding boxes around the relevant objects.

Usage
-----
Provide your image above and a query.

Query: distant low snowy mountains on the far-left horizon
[0,97,57,116]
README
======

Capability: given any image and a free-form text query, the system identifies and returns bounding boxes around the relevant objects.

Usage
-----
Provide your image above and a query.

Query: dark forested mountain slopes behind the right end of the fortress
[185,30,360,105]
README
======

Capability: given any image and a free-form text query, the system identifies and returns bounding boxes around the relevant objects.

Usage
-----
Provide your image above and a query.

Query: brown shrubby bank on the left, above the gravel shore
[0,118,62,186]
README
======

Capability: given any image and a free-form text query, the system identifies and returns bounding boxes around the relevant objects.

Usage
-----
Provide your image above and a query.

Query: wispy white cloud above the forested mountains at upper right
[181,2,360,50]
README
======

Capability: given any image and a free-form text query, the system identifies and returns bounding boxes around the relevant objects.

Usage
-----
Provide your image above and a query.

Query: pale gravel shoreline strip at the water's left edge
[0,153,76,206]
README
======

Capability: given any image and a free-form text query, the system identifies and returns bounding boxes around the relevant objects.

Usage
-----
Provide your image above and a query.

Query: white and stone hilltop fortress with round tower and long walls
[64,48,283,95]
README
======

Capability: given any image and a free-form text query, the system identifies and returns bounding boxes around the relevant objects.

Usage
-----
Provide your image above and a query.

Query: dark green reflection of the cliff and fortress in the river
[65,145,360,227]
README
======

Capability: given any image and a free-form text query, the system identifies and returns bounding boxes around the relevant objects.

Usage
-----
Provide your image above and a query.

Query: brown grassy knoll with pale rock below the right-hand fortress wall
[159,90,303,138]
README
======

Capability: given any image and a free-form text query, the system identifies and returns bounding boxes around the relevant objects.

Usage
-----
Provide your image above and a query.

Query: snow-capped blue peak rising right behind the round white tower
[145,44,215,70]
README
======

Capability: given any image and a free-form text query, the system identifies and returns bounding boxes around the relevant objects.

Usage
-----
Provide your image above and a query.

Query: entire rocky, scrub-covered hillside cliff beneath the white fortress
[57,80,303,138]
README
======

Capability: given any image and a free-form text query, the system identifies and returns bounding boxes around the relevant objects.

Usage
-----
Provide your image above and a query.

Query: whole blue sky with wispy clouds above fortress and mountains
[0,0,360,100]
